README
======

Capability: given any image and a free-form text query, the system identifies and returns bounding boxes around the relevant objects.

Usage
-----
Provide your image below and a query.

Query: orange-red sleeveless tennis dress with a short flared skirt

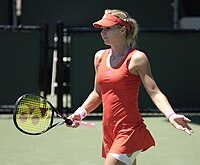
[97,49,155,158]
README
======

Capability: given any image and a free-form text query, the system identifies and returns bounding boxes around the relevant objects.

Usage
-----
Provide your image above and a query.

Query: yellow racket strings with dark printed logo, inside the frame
[16,96,53,134]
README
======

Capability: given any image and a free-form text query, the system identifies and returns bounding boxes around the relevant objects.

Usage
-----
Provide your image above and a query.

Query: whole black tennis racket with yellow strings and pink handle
[13,94,95,135]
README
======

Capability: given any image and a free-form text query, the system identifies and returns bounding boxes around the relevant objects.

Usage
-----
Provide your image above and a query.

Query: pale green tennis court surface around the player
[0,117,200,165]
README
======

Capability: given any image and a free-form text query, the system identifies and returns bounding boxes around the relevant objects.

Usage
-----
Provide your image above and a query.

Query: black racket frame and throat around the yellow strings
[13,93,73,135]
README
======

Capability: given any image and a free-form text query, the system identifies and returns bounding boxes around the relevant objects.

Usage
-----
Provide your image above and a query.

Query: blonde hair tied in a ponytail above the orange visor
[105,9,138,47]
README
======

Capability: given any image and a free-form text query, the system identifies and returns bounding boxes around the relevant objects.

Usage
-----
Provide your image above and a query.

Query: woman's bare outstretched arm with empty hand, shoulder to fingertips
[129,51,192,134]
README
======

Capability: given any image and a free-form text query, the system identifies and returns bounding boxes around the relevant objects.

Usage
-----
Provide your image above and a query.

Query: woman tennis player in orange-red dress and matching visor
[67,9,193,165]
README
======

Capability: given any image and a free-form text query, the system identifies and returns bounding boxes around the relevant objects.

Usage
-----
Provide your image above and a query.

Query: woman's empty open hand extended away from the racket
[169,114,194,135]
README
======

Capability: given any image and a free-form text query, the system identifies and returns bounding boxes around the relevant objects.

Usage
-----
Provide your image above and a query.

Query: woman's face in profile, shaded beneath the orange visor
[101,25,122,45]
